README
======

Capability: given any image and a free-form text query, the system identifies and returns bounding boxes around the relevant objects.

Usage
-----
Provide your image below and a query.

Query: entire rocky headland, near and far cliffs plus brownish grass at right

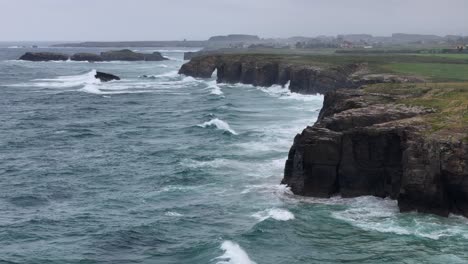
[179,54,468,217]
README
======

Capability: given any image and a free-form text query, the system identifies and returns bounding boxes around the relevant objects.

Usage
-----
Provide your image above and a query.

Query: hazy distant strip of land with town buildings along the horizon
[49,33,468,52]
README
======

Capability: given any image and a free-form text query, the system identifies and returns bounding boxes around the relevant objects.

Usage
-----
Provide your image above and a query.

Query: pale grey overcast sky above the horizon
[0,0,468,41]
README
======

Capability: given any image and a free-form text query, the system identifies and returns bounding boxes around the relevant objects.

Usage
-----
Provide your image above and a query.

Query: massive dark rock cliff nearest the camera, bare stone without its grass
[282,89,468,217]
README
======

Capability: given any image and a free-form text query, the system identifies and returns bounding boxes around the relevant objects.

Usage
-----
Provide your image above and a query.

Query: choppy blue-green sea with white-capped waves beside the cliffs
[0,47,468,264]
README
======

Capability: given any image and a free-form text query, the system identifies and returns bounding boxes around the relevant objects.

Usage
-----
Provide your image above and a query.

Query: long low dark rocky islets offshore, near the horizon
[19,49,168,62]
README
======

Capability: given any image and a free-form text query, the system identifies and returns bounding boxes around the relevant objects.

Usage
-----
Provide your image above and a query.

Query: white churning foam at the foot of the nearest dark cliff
[332,196,468,240]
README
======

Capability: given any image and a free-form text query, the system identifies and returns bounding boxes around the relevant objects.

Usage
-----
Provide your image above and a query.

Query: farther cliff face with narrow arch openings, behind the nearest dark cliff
[179,54,417,94]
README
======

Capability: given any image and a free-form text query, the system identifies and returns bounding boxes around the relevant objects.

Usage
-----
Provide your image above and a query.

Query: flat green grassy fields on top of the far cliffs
[200,49,468,82]
